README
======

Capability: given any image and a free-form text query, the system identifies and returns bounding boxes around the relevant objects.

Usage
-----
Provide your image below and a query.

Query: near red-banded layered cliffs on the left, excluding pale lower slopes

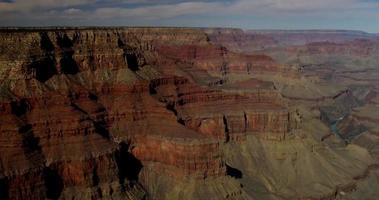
[0,28,290,199]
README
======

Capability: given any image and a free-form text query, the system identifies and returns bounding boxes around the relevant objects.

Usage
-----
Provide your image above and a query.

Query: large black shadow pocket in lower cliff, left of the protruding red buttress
[116,142,143,188]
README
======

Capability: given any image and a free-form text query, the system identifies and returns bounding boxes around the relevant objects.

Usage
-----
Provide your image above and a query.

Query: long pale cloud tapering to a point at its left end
[87,0,379,20]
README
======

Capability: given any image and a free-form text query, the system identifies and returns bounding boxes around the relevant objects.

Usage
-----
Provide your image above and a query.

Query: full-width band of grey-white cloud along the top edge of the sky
[0,0,378,18]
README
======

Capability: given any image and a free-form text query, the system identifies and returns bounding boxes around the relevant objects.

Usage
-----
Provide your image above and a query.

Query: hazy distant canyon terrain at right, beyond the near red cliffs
[205,27,378,199]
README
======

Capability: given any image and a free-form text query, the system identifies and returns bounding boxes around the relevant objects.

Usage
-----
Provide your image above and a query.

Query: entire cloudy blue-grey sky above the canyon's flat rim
[0,0,379,33]
